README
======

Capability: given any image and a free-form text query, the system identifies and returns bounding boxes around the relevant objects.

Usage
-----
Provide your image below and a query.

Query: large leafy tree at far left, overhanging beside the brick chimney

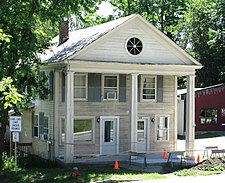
[0,0,100,163]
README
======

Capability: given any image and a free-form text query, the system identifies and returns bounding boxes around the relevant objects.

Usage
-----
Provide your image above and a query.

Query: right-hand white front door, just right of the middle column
[137,118,149,153]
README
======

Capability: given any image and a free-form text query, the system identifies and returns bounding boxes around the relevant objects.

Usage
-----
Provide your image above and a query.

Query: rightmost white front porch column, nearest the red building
[185,75,195,156]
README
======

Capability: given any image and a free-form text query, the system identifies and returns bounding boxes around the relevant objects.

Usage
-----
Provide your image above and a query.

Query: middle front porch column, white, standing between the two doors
[130,74,138,152]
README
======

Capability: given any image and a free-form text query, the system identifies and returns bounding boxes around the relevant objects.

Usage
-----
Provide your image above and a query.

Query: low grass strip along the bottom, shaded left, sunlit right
[0,167,165,183]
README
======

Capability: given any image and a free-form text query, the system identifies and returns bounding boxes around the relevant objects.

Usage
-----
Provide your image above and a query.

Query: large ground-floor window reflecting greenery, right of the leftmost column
[74,119,94,142]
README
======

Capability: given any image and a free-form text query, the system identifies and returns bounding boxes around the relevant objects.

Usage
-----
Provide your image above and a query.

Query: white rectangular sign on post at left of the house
[10,116,21,175]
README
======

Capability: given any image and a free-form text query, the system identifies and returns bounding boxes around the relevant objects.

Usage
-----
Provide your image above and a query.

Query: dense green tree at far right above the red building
[184,0,225,87]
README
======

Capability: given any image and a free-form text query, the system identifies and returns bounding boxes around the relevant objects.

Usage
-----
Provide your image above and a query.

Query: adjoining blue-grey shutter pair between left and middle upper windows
[88,73,101,102]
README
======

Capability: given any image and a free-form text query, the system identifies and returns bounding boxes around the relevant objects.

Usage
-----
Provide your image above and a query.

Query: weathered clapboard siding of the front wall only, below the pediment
[71,76,175,154]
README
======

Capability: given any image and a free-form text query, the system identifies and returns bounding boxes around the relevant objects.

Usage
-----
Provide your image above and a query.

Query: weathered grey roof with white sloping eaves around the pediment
[41,14,202,68]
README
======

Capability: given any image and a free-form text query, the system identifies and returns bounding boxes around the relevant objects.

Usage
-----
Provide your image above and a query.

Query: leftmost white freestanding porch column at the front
[64,71,74,163]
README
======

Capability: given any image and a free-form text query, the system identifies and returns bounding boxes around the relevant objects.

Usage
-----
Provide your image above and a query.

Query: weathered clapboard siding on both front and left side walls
[22,75,175,159]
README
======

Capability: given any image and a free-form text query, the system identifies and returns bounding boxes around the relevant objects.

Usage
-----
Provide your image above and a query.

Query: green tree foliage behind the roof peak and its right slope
[109,0,188,42]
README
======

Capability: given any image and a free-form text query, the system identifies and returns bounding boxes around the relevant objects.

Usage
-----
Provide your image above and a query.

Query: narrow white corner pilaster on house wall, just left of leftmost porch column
[53,71,61,157]
